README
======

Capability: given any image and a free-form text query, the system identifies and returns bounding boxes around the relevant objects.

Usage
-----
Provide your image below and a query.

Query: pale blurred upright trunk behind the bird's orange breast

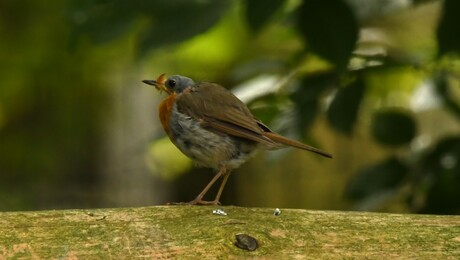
[101,72,168,207]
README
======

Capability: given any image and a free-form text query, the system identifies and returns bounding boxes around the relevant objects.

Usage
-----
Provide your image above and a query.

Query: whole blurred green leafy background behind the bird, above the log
[0,0,460,214]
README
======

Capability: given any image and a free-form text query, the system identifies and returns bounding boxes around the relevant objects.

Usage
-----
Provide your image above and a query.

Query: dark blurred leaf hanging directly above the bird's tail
[291,72,337,133]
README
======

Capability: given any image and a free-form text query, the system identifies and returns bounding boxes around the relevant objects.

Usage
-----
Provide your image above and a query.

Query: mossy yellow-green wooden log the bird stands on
[0,206,460,259]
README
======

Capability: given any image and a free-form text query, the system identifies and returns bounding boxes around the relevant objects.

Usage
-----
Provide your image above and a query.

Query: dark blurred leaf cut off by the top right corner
[437,0,460,55]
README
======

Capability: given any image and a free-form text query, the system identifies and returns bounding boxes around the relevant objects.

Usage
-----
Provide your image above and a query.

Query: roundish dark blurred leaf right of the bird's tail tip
[371,109,416,146]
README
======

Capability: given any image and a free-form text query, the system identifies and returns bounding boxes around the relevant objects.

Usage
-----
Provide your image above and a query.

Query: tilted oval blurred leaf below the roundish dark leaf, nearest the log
[345,157,408,200]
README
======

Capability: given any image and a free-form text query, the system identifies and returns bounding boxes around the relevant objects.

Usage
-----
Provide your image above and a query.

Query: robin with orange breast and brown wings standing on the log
[142,74,332,205]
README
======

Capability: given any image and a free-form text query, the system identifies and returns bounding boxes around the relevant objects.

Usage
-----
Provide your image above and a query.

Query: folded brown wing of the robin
[177,82,280,148]
